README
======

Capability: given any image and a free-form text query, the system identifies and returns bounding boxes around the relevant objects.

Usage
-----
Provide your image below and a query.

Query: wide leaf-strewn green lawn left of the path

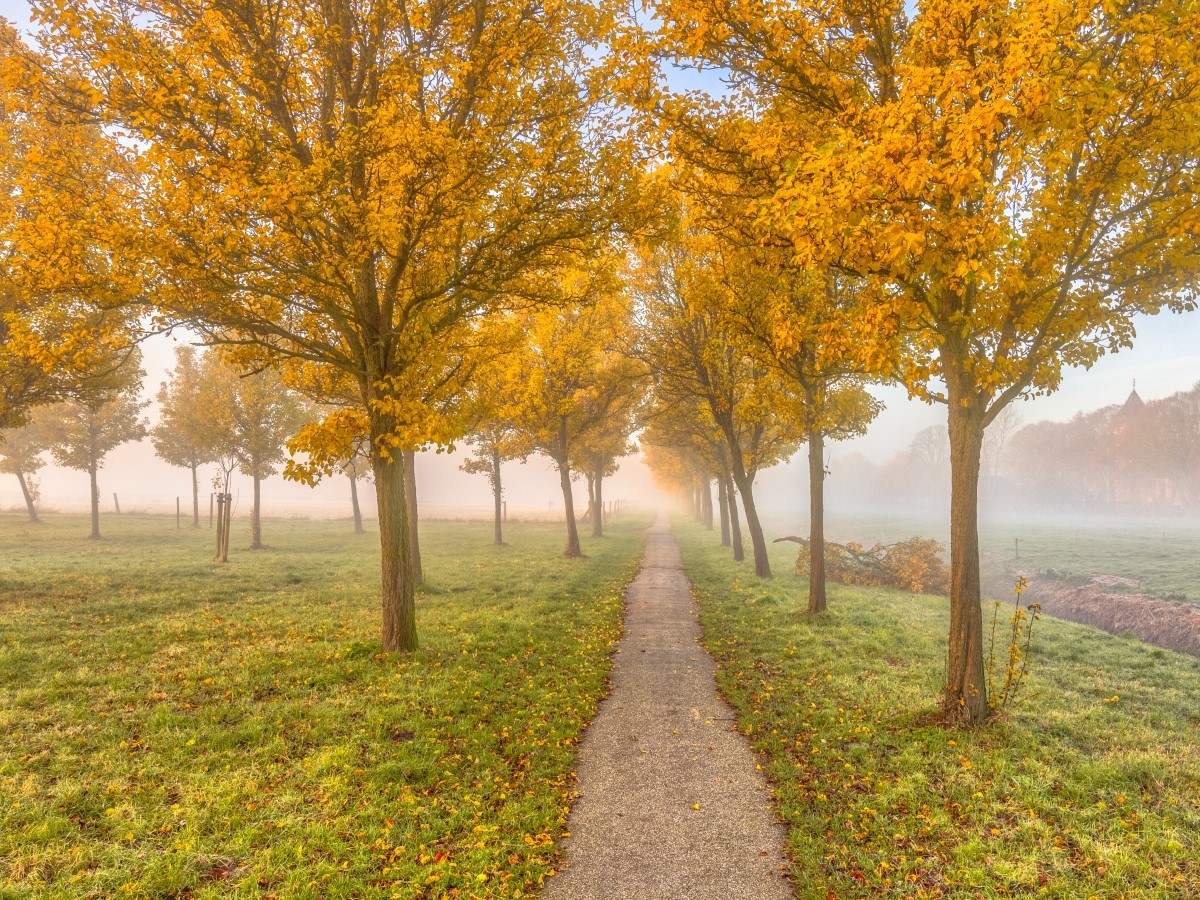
[0,515,648,898]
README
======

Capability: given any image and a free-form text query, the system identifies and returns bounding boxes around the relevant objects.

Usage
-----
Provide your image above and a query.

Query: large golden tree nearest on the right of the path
[655,0,1200,722]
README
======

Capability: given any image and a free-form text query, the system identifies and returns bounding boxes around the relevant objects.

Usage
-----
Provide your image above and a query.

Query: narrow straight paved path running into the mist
[544,514,792,900]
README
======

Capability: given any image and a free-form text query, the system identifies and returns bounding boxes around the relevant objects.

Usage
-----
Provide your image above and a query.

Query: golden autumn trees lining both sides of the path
[0,0,1200,722]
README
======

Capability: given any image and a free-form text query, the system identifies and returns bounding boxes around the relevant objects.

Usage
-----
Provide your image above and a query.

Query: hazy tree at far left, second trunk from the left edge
[34,350,149,540]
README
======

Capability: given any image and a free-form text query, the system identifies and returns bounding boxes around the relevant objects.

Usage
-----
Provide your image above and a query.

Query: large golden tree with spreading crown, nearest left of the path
[42,0,637,652]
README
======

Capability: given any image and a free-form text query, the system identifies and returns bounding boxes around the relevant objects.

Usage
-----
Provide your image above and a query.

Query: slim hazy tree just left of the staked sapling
[150,346,214,528]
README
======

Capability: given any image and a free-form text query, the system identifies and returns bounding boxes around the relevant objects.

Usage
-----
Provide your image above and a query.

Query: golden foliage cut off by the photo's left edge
[0,27,140,428]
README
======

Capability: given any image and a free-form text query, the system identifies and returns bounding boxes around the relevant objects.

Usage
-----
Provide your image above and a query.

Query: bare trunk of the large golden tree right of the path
[942,400,988,724]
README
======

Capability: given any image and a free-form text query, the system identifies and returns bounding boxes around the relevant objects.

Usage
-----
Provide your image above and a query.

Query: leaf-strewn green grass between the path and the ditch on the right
[676,522,1200,900]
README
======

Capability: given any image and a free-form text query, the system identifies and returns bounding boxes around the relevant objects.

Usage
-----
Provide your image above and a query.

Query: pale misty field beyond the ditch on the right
[806,514,1200,604]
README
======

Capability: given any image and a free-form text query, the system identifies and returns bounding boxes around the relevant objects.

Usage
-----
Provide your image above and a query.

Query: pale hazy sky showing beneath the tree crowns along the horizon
[0,0,1200,517]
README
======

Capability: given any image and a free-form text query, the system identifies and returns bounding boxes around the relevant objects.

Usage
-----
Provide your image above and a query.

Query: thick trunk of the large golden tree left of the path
[372,453,416,653]
